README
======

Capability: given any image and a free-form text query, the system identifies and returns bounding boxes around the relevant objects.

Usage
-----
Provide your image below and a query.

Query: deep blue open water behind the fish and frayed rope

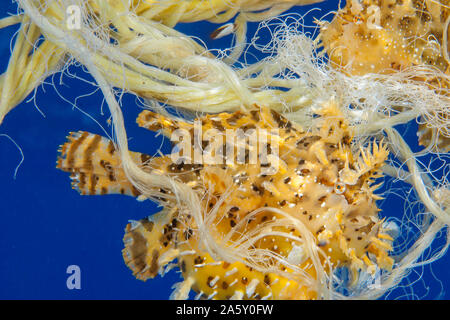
[0,1,450,299]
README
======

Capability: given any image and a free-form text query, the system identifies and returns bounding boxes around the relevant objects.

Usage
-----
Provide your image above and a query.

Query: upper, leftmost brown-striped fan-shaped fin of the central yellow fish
[56,131,145,196]
